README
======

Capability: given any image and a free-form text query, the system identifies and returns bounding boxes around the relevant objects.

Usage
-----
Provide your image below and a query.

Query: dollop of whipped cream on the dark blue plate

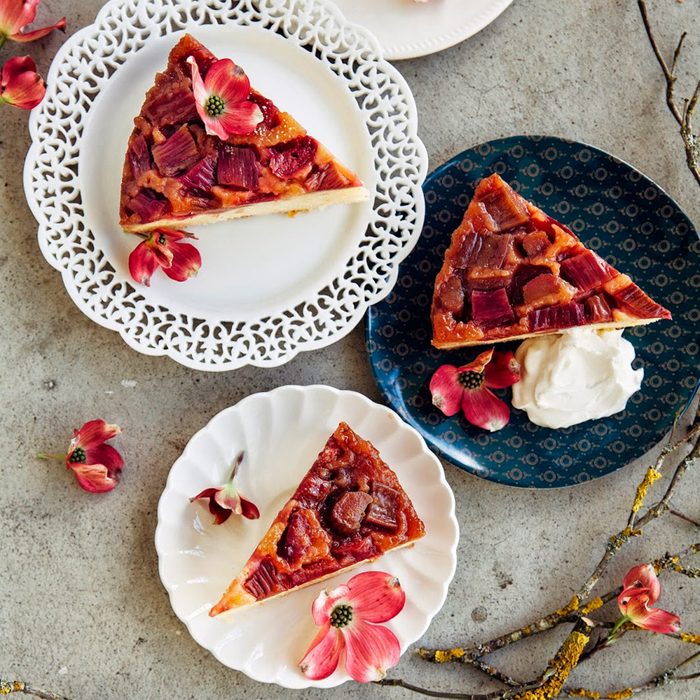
[513,328,644,428]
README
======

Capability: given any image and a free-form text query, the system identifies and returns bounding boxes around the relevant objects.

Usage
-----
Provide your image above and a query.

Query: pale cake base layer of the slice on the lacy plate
[122,187,369,233]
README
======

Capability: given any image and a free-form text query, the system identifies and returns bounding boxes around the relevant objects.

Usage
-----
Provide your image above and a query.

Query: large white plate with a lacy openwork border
[24,0,427,370]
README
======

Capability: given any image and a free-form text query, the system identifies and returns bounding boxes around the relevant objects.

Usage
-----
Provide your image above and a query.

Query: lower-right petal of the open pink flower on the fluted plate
[343,620,401,683]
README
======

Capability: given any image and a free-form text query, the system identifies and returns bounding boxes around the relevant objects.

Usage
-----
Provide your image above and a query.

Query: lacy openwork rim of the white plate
[24,0,428,371]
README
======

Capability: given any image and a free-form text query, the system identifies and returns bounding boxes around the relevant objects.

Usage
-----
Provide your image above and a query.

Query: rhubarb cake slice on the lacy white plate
[119,34,367,232]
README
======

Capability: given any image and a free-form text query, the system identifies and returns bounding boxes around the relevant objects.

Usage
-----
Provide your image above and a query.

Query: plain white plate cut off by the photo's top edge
[335,0,513,61]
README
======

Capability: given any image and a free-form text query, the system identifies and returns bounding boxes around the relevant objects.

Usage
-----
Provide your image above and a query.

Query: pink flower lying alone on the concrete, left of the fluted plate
[37,418,124,493]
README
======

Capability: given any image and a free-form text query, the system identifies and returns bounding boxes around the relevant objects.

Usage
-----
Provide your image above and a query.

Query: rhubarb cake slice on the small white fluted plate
[209,423,425,616]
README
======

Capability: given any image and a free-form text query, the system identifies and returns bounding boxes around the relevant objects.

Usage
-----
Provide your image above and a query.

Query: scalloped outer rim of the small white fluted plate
[154,384,460,689]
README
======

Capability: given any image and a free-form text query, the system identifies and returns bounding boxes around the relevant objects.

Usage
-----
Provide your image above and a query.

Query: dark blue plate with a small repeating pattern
[367,136,700,488]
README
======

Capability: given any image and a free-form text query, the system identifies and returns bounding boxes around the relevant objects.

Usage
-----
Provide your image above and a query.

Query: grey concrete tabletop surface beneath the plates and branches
[0,0,700,700]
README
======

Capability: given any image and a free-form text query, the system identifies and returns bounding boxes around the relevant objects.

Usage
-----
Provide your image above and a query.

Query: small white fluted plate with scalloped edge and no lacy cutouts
[155,386,459,688]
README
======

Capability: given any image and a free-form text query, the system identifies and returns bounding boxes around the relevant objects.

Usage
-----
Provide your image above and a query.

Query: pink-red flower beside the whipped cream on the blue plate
[430,348,520,431]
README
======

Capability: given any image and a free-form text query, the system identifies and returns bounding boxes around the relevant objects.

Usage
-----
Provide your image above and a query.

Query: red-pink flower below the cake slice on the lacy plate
[129,228,202,286]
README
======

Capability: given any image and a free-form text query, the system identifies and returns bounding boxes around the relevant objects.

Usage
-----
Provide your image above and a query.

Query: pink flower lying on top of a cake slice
[187,56,264,141]
